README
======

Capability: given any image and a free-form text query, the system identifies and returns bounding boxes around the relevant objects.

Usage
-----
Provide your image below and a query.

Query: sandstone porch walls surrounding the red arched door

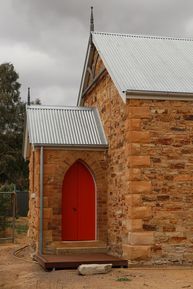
[29,148,107,253]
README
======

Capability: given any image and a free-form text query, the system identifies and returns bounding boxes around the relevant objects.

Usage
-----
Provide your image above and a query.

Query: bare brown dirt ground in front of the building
[0,219,193,289]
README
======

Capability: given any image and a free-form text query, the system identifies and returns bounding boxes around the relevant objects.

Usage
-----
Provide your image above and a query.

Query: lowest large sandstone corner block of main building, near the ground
[122,244,151,260]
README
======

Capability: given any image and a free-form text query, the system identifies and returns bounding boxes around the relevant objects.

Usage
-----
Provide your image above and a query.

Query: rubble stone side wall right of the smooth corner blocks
[128,100,193,263]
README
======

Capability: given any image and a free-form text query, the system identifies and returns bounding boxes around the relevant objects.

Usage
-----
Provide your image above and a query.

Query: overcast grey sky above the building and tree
[0,0,193,105]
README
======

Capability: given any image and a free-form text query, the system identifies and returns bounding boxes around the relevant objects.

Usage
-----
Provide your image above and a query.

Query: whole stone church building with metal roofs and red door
[24,19,193,263]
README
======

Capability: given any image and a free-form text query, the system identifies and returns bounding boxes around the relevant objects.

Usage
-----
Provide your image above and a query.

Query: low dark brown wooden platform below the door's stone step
[35,253,128,270]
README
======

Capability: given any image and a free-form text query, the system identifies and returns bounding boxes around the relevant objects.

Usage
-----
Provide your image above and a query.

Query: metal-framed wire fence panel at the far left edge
[0,192,16,243]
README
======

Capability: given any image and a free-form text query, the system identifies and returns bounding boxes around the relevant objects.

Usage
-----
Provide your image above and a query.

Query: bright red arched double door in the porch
[62,161,95,241]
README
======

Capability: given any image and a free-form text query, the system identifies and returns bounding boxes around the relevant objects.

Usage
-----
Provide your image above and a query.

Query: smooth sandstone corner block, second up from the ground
[128,232,154,245]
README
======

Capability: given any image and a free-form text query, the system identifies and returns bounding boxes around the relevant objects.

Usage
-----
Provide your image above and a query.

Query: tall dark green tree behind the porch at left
[0,63,28,189]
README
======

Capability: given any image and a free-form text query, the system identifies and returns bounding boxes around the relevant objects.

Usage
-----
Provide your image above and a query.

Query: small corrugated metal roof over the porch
[27,105,107,147]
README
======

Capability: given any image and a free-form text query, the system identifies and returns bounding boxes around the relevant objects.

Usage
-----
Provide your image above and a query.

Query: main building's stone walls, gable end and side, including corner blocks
[84,59,193,263]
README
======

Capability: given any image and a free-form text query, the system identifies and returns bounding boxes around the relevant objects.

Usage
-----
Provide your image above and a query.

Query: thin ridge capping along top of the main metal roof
[92,31,193,41]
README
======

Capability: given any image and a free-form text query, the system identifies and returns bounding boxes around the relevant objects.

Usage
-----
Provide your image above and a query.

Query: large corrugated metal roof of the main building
[92,32,193,100]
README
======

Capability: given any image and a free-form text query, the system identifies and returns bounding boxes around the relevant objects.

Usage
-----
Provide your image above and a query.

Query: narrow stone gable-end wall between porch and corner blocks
[84,73,129,255]
